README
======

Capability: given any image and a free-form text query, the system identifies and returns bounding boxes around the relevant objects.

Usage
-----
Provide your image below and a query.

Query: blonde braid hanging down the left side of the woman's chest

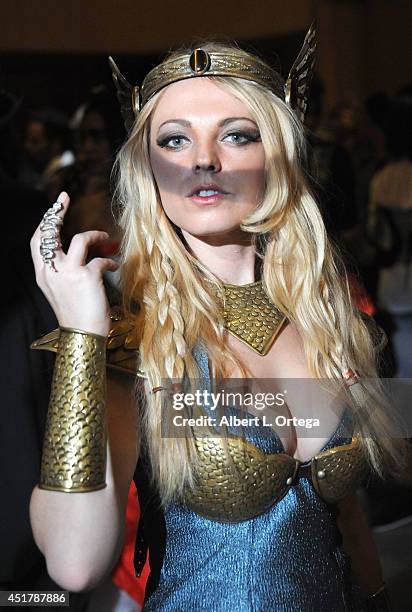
[141,211,200,503]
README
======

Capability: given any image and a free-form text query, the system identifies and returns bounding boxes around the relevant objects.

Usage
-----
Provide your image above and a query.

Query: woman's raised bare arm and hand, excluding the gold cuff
[30,192,138,591]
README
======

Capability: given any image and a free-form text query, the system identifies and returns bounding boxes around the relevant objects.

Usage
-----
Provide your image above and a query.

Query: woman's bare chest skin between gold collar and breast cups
[212,323,344,462]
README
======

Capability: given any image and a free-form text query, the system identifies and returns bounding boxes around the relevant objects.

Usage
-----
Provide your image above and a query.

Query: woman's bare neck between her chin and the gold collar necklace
[182,230,256,285]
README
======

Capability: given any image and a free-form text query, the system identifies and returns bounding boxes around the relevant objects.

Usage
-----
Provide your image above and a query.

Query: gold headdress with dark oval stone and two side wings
[109,22,316,132]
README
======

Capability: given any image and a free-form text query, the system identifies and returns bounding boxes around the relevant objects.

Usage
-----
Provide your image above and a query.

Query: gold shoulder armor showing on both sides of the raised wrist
[30,307,146,378]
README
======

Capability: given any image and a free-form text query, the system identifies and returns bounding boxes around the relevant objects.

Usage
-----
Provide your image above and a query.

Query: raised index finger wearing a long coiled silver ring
[30,191,70,268]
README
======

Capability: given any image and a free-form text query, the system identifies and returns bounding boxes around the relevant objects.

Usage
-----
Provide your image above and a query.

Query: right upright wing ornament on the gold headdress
[285,21,317,123]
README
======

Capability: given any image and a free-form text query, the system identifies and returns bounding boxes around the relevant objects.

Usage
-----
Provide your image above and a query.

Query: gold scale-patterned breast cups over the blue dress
[185,431,367,523]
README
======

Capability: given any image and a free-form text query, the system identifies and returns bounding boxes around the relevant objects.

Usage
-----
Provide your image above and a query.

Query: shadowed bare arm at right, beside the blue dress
[337,494,383,595]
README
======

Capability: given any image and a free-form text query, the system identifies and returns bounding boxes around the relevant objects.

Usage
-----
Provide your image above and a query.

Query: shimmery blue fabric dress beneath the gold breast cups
[137,350,366,612]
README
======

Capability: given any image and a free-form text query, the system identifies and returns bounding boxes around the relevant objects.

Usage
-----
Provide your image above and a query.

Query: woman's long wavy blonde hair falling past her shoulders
[116,43,403,503]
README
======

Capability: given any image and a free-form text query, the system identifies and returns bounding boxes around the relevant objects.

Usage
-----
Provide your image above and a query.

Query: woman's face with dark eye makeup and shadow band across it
[150,78,265,237]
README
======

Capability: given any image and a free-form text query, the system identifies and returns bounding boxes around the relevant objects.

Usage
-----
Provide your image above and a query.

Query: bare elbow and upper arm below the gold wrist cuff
[30,374,138,591]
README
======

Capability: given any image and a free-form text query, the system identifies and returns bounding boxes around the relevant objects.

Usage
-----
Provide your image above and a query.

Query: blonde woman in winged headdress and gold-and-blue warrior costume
[27,33,399,611]
